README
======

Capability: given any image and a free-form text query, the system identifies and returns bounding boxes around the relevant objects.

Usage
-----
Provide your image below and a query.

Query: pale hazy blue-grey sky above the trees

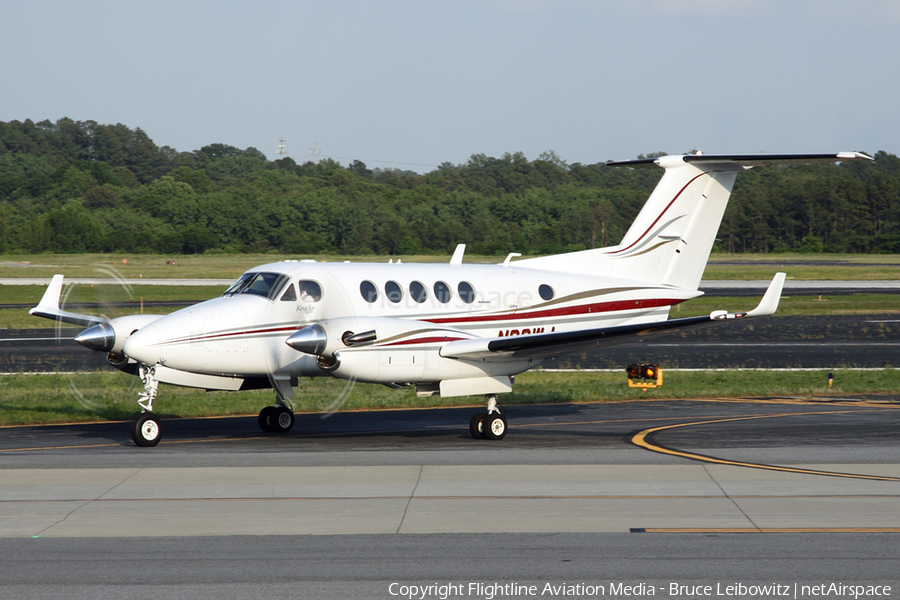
[0,0,900,172]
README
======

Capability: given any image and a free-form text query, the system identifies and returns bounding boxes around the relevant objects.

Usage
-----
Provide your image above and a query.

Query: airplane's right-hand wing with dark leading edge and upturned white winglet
[440,273,785,361]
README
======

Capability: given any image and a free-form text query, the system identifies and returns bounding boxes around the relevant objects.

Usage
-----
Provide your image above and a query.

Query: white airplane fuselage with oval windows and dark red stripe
[125,261,700,382]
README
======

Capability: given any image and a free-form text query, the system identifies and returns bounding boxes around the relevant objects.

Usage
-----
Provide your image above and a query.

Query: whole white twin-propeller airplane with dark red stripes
[30,152,872,446]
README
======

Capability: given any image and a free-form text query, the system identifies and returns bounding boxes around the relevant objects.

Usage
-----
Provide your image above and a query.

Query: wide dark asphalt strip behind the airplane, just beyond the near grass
[7,314,900,372]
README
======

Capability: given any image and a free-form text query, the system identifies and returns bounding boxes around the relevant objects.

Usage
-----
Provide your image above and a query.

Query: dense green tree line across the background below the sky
[0,118,900,255]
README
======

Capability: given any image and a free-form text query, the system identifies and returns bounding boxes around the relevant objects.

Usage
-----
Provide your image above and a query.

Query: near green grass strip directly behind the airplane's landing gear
[0,369,900,425]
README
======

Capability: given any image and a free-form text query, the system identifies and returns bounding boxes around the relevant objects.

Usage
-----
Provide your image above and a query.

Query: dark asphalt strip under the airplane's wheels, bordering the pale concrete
[0,395,900,468]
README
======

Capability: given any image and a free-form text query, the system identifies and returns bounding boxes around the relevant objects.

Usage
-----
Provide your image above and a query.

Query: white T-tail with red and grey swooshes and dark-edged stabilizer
[515,152,872,290]
